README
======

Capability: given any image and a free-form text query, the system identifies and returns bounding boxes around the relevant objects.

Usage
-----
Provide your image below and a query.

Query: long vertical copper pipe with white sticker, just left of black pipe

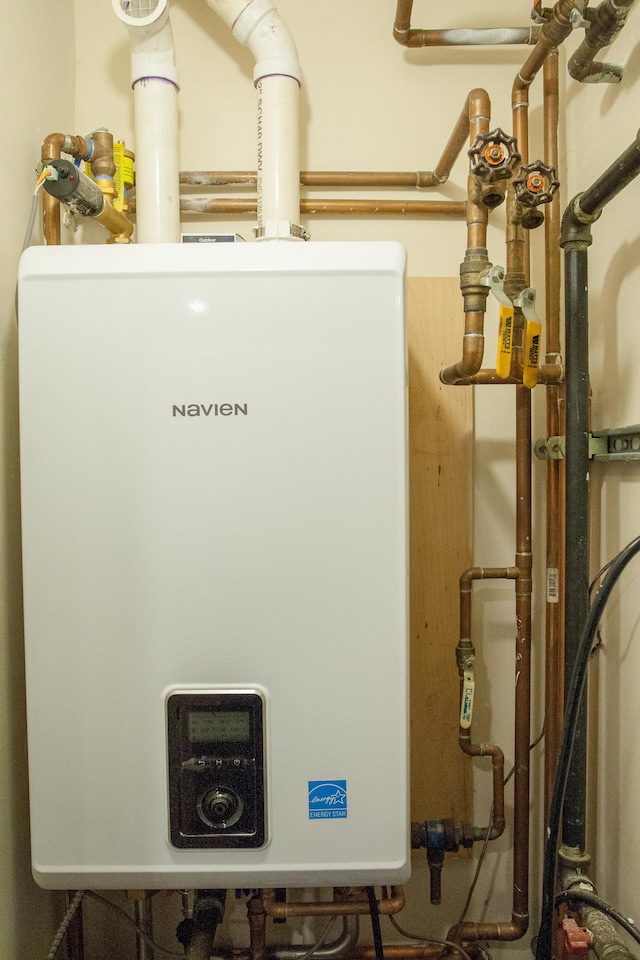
[544,50,564,823]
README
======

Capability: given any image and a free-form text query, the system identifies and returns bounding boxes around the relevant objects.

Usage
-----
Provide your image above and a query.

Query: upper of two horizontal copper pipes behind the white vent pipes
[180,170,446,189]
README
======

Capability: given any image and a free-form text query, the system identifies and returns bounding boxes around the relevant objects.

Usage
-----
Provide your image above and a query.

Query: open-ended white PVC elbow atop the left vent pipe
[111,0,178,89]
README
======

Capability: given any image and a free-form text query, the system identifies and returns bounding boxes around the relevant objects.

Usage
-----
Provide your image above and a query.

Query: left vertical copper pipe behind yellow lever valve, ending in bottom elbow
[440,88,491,384]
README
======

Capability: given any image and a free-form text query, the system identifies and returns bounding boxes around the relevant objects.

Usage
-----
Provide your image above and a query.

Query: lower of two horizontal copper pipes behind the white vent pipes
[129,197,466,220]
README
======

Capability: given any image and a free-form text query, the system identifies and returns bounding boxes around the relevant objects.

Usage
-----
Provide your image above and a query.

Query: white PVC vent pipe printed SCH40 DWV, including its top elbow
[207,0,304,239]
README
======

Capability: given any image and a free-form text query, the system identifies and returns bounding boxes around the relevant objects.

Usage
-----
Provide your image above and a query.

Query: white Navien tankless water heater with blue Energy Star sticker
[19,243,409,888]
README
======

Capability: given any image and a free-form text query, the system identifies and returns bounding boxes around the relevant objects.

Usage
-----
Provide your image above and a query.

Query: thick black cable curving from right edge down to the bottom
[536,537,640,960]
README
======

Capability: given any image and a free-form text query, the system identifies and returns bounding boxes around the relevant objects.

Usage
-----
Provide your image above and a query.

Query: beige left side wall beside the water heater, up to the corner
[0,0,74,960]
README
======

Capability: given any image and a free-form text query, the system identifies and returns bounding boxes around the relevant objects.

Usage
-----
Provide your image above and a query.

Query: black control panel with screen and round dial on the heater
[167,690,266,849]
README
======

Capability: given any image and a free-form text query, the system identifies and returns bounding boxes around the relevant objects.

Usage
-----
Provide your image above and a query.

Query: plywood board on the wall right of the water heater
[408,278,473,820]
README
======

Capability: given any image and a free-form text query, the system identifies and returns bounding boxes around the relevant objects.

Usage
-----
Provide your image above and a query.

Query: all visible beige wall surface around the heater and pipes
[0,0,640,960]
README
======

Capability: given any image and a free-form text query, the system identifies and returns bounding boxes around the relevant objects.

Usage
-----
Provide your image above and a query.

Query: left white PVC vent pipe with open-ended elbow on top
[111,0,180,243]
